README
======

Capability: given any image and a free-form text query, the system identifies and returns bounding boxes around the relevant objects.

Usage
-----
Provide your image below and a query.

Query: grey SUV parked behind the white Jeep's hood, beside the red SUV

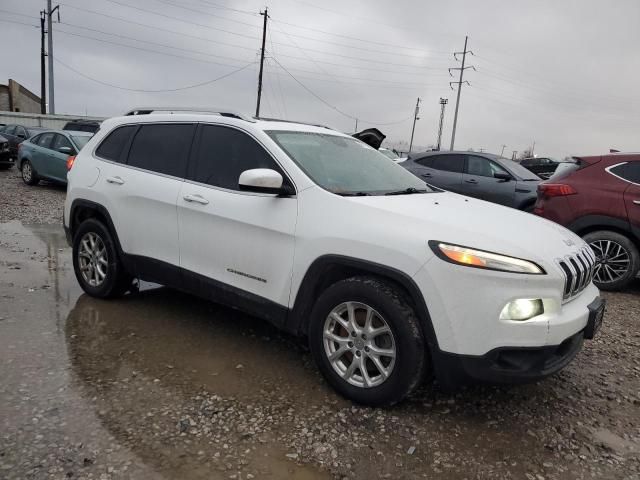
[399,151,540,211]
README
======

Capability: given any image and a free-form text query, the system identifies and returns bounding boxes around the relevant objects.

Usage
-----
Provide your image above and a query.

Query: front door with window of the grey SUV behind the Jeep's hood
[462,155,516,206]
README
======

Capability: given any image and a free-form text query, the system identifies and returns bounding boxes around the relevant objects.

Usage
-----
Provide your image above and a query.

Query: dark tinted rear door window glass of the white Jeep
[127,123,195,178]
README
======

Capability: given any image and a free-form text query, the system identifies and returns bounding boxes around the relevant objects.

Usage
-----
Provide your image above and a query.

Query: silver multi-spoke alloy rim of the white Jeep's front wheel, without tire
[323,302,396,388]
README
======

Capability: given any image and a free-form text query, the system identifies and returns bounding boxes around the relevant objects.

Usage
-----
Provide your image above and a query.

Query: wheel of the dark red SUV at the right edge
[583,230,640,291]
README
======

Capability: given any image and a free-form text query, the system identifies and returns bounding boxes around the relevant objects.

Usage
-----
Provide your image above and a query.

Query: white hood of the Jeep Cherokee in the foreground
[352,192,586,269]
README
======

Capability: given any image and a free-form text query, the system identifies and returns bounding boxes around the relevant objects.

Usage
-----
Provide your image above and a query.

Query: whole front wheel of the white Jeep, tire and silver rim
[309,277,428,406]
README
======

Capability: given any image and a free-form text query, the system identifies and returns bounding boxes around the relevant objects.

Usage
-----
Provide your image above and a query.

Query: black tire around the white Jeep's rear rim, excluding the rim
[73,219,123,298]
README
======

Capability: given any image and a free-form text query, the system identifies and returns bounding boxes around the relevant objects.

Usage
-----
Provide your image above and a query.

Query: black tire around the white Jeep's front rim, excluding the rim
[309,278,427,406]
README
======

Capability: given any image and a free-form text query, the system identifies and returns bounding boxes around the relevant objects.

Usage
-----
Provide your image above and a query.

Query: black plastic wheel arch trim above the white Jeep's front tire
[286,255,439,352]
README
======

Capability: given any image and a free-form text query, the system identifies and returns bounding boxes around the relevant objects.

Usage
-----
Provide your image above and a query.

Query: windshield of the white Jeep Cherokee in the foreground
[266,130,433,195]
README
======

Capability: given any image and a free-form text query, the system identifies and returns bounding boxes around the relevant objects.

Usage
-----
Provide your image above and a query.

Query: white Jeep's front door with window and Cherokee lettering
[178,124,298,313]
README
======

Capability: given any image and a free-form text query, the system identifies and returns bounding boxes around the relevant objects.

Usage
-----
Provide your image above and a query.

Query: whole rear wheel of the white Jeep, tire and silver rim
[73,218,133,298]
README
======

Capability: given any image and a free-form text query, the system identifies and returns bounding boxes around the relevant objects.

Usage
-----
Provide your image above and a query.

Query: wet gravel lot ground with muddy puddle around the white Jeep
[0,169,640,480]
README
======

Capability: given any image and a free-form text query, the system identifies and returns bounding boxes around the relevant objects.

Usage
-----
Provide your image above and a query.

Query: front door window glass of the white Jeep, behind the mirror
[189,125,286,190]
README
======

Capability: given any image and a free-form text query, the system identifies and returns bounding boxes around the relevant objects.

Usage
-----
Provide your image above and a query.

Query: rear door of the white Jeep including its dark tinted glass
[96,123,195,286]
